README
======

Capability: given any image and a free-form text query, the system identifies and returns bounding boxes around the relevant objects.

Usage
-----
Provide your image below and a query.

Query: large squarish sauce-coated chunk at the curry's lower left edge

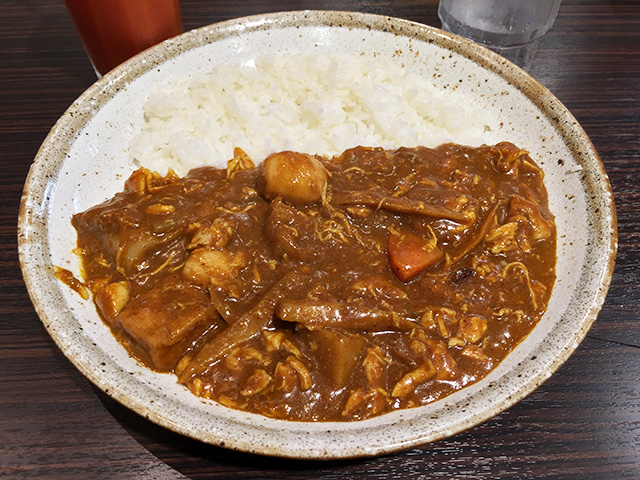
[114,275,222,371]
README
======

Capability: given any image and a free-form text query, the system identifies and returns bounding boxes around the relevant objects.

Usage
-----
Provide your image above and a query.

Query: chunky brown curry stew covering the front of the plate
[73,143,556,421]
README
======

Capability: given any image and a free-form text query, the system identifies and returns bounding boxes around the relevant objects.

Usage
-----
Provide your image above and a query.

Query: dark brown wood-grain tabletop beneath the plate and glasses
[0,0,640,480]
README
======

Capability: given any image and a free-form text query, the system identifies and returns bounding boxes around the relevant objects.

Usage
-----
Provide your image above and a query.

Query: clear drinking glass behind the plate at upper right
[438,0,562,69]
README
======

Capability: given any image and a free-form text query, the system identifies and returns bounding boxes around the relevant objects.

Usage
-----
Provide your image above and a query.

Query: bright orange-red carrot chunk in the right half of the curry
[387,232,443,282]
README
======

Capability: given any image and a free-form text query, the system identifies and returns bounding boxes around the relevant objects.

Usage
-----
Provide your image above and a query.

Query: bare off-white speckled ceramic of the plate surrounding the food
[19,12,617,459]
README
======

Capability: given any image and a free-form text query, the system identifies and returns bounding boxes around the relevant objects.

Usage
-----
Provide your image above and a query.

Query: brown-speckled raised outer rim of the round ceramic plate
[18,11,617,459]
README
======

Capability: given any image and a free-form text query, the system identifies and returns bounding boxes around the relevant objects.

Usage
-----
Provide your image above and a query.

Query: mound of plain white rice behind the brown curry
[129,54,484,175]
